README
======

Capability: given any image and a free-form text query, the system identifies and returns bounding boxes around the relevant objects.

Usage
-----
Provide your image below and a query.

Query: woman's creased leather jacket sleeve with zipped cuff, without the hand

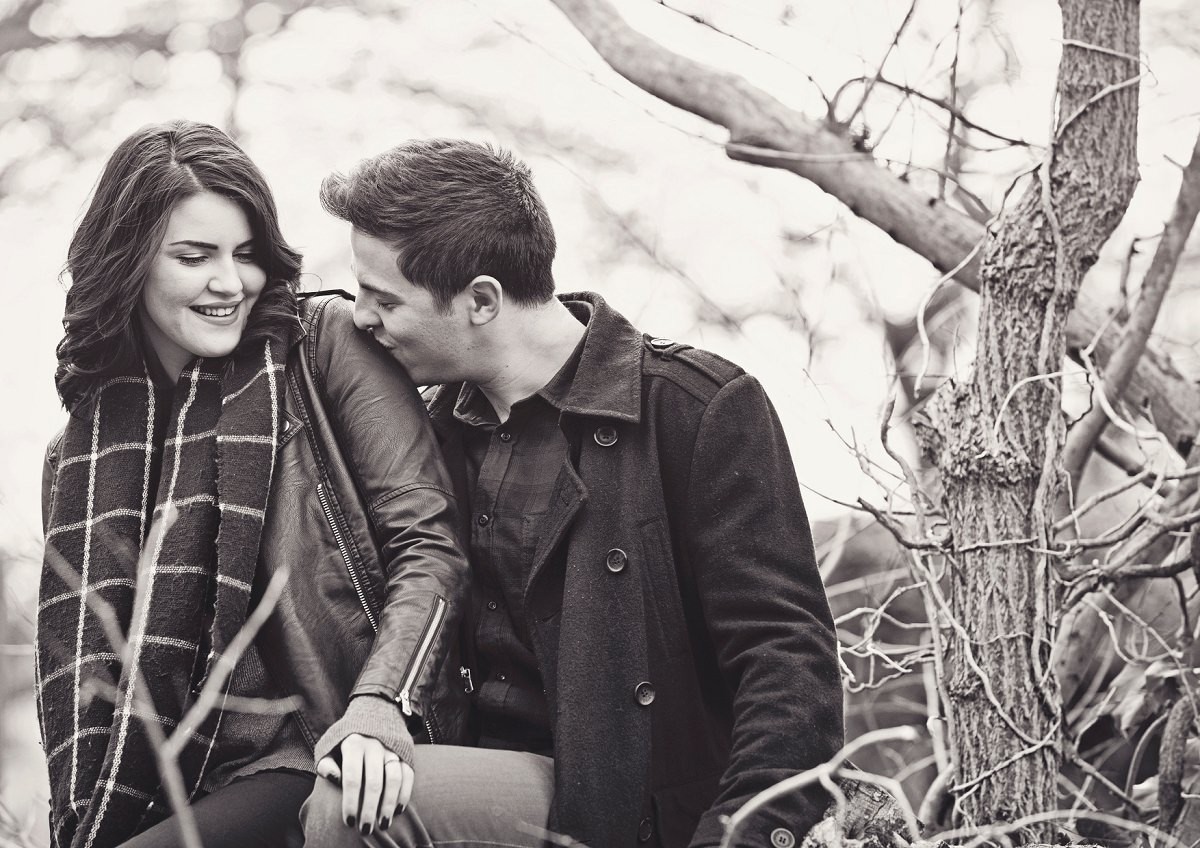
[313,300,469,717]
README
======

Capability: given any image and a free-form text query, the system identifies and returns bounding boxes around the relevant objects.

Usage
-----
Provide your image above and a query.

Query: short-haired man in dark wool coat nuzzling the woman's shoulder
[305,140,842,848]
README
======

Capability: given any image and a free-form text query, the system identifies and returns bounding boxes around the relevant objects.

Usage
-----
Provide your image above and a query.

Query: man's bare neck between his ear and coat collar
[478,299,586,421]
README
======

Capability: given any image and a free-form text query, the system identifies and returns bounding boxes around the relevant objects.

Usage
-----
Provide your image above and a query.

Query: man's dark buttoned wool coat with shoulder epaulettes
[427,294,842,848]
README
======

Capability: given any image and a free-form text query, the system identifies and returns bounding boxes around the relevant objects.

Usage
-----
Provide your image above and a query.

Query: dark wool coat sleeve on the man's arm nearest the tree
[685,374,844,847]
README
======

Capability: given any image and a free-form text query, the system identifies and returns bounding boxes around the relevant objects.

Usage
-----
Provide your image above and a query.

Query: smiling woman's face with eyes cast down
[140,192,266,379]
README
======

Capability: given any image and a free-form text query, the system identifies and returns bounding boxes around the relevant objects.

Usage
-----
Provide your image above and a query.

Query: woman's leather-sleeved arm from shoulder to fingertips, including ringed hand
[304,300,469,832]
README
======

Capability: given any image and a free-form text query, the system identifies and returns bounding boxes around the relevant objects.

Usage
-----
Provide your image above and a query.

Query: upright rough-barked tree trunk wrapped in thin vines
[918,0,1139,840]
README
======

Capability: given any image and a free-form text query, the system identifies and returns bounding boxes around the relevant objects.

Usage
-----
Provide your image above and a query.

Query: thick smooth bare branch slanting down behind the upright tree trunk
[553,0,1200,453]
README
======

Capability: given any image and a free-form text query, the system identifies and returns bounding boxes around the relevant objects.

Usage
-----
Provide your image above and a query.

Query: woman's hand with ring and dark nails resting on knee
[317,733,416,834]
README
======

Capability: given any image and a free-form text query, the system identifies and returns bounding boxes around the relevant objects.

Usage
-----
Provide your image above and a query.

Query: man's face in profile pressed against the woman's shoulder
[350,228,470,386]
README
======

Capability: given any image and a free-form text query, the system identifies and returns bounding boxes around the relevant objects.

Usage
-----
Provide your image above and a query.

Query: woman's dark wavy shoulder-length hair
[54,120,300,411]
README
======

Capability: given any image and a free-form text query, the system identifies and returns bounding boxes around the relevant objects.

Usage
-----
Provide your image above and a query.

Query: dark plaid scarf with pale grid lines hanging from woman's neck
[37,341,286,848]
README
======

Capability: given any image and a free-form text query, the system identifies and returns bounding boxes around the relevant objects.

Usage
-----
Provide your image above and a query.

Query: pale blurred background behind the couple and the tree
[0,0,1200,844]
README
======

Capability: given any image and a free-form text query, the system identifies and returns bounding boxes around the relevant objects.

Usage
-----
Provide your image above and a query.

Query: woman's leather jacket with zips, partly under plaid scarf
[42,294,469,746]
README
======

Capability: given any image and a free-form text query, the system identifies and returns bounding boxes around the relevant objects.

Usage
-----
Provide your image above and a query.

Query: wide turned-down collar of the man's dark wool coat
[427,291,644,423]
